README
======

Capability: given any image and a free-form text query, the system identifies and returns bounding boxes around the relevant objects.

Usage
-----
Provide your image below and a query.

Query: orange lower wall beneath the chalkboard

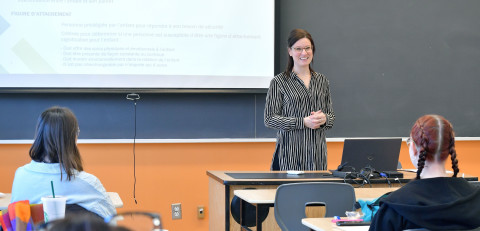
[0,141,480,231]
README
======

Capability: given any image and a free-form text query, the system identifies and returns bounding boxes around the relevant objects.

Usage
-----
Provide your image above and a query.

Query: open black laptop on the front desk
[330,138,403,178]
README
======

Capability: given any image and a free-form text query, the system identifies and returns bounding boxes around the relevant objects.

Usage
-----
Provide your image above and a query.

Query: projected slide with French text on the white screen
[0,0,274,88]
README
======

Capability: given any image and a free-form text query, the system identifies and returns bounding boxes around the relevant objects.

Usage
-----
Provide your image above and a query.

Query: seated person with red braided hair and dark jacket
[370,115,480,231]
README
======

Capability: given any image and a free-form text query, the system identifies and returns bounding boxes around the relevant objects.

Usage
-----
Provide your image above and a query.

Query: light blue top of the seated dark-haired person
[11,160,116,218]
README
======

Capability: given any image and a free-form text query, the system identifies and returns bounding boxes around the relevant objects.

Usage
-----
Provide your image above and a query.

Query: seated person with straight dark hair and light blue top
[11,107,116,218]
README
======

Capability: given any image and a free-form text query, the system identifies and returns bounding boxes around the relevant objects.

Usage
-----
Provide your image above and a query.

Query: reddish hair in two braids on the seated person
[410,115,460,179]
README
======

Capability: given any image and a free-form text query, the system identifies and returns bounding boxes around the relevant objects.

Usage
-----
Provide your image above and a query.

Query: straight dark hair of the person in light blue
[29,106,83,180]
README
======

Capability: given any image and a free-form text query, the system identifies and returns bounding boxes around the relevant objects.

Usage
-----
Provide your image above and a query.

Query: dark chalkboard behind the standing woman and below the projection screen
[0,0,480,140]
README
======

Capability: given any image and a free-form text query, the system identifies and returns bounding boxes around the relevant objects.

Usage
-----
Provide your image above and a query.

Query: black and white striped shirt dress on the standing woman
[264,72,335,170]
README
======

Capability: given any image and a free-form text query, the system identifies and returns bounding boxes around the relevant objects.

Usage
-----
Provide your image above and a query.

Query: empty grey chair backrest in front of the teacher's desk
[274,182,355,231]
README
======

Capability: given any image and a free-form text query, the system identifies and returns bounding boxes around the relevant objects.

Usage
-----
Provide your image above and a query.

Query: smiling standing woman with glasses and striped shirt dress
[264,29,335,170]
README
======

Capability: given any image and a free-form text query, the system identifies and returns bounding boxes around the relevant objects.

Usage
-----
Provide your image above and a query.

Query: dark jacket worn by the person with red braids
[370,177,480,231]
